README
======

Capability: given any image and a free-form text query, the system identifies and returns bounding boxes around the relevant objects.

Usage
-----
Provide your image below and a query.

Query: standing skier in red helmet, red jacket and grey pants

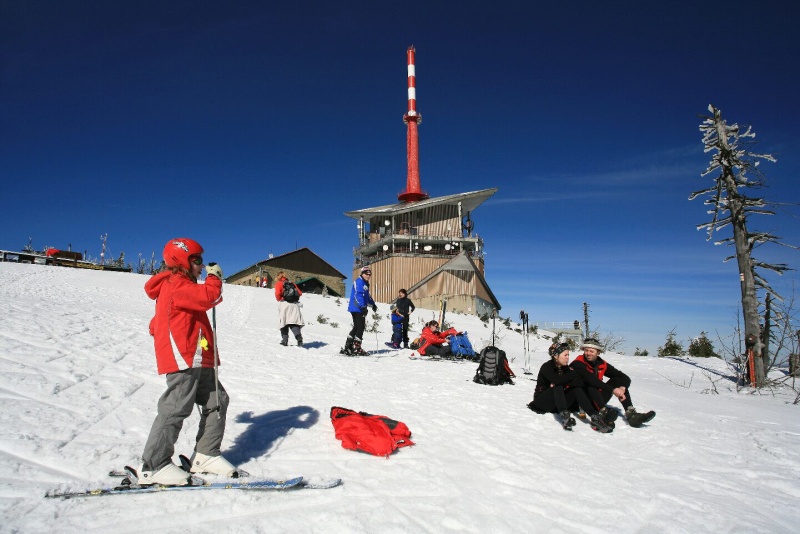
[139,238,237,486]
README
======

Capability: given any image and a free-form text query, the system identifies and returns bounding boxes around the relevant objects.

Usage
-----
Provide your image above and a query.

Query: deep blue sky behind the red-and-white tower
[0,0,800,353]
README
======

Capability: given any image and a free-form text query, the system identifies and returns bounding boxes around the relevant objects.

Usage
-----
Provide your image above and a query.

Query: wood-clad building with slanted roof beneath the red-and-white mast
[345,188,500,316]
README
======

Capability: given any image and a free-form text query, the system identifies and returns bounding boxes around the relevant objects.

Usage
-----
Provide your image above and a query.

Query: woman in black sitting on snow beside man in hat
[528,343,614,434]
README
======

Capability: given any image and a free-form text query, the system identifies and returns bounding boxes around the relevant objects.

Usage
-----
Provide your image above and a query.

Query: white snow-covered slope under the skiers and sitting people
[0,264,800,533]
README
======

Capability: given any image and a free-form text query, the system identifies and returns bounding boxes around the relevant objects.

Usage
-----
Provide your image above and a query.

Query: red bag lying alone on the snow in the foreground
[331,406,414,457]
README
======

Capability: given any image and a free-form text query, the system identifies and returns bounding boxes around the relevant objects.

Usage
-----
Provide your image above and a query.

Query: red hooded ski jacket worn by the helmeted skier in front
[144,271,222,375]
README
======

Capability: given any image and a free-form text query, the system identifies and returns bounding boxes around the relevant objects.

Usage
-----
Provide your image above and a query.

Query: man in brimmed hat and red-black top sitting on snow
[570,337,656,427]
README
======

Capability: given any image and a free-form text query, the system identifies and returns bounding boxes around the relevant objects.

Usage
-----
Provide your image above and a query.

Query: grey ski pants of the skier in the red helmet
[142,367,229,471]
